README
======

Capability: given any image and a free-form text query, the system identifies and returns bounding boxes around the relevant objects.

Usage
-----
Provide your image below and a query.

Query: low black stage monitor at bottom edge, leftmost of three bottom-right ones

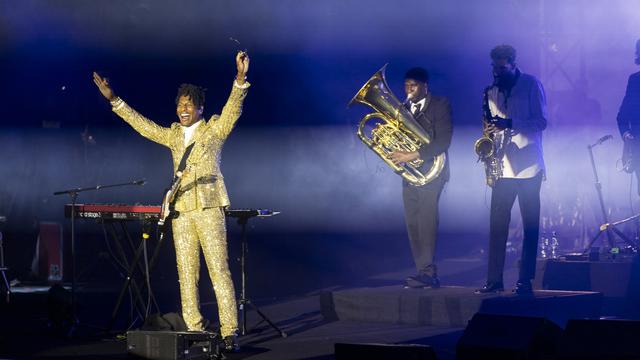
[335,343,438,360]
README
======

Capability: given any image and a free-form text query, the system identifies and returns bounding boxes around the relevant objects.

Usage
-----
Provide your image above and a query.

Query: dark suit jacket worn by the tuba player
[405,96,453,183]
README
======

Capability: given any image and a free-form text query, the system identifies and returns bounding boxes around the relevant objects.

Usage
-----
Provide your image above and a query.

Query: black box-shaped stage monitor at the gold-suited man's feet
[127,330,221,360]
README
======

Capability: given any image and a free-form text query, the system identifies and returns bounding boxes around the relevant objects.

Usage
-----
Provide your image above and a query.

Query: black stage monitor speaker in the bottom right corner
[560,320,640,359]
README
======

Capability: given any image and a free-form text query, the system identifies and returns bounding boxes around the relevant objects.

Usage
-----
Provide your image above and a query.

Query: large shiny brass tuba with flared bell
[348,65,446,186]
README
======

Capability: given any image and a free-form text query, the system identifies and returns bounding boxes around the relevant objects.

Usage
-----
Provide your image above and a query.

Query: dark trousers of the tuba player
[402,175,447,275]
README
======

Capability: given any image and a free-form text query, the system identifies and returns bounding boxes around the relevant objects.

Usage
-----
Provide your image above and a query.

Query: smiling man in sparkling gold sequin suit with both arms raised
[93,52,250,350]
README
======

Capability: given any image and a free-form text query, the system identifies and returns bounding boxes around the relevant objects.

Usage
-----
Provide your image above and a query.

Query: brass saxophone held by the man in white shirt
[474,83,511,187]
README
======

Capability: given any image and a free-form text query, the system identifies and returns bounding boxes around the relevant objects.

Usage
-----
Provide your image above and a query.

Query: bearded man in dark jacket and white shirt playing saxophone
[476,45,547,295]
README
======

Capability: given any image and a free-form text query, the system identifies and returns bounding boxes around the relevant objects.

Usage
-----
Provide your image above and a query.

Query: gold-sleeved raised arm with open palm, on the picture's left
[93,72,170,146]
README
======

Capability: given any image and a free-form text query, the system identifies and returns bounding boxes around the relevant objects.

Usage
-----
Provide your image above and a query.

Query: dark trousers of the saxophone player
[487,172,542,282]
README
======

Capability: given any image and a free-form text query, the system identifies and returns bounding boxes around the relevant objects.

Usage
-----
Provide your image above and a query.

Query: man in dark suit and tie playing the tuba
[390,68,452,288]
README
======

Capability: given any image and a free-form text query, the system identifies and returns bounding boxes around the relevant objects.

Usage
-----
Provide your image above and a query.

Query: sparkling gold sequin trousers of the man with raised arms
[172,207,238,336]
